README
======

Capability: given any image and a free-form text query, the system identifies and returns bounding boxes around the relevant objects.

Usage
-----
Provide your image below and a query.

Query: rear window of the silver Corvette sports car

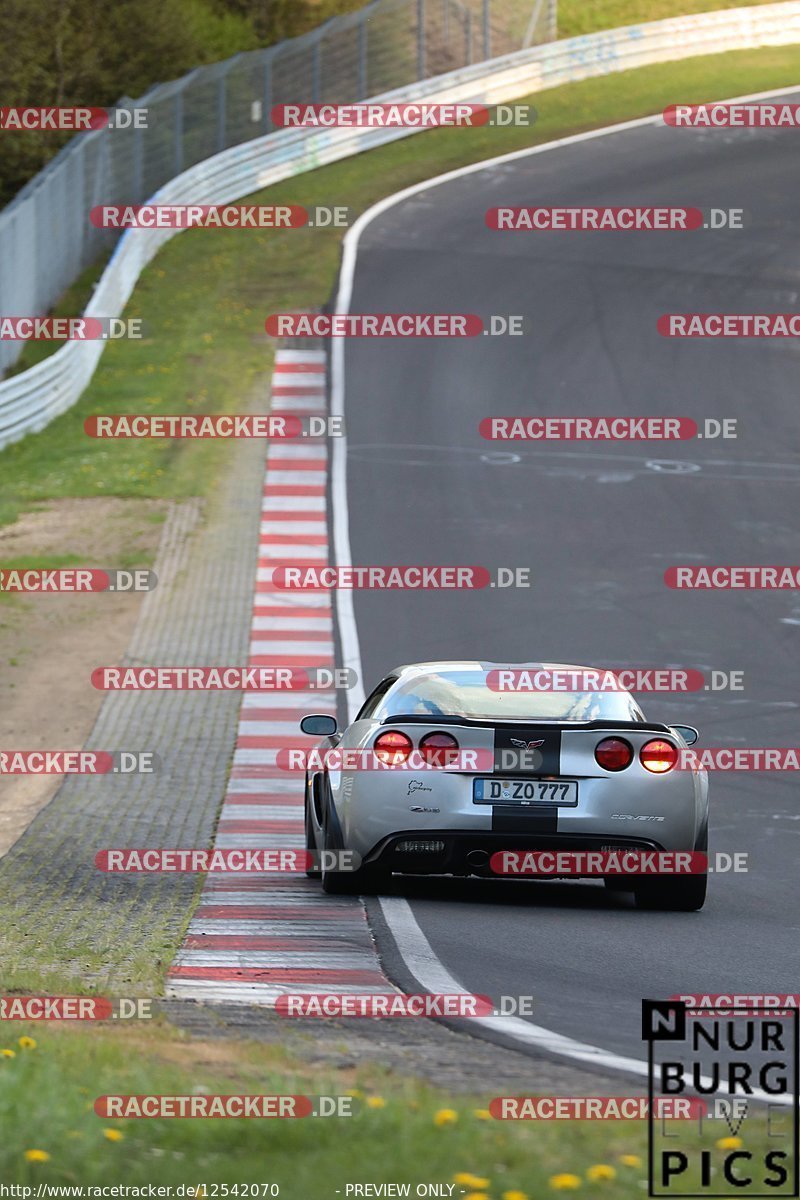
[372,671,644,721]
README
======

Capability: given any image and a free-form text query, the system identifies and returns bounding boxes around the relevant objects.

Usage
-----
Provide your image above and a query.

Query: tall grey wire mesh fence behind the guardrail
[0,0,557,377]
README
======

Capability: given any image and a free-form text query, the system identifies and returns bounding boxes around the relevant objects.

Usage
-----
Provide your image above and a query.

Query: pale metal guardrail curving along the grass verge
[0,0,800,449]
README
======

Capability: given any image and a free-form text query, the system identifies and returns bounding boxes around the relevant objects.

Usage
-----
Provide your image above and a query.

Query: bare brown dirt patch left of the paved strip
[0,498,167,857]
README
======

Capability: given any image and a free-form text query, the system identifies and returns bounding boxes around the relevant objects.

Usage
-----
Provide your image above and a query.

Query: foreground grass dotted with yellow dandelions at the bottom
[0,1020,782,1200]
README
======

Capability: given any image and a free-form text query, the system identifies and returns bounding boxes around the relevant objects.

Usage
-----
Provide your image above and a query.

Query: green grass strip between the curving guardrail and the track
[0,46,800,522]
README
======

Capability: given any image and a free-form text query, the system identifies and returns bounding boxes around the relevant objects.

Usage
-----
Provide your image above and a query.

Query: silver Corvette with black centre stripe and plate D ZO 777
[301,662,709,912]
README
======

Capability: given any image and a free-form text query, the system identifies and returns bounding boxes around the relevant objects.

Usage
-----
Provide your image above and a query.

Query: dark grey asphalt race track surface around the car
[344,103,800,1058]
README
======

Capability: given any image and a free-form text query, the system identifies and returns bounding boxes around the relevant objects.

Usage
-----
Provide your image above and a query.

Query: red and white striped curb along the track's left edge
[167,350,392,1006]
